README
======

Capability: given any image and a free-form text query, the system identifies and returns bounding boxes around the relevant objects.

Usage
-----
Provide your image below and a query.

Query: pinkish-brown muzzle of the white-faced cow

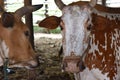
[62,56,85,73]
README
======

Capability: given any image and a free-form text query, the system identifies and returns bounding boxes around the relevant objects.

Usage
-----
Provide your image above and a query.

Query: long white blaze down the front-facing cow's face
[62,6,91,56]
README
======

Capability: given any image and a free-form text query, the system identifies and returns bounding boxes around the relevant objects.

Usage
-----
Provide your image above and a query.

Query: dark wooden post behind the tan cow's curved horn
[24,0,34,49]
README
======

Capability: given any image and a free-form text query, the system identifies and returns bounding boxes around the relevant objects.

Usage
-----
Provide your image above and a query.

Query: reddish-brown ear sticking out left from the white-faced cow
[38,16,60,29]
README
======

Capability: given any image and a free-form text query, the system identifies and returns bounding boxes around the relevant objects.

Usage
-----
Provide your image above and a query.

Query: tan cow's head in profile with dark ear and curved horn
[0,5,42,69]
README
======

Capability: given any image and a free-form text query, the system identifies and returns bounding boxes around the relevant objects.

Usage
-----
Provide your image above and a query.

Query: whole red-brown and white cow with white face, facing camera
[39,0,120,80]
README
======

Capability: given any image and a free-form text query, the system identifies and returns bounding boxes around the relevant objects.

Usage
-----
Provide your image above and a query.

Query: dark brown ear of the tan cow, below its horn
[1,12,14,28]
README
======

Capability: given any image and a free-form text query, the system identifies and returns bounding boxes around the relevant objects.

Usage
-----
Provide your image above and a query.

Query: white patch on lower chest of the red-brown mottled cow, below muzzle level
[75,68,110,80]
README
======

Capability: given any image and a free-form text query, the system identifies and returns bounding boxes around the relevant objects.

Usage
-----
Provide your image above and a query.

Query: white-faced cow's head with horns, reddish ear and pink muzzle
[39,0,97,73]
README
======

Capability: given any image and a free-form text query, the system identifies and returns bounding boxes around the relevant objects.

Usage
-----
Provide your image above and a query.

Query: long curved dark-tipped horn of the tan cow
[15,4,43,18]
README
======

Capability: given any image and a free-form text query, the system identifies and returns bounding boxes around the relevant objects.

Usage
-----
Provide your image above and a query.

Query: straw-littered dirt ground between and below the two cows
[0,34,74,80]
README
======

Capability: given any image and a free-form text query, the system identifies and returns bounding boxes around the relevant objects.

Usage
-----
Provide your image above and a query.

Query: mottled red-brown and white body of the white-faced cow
[80,15,120,80]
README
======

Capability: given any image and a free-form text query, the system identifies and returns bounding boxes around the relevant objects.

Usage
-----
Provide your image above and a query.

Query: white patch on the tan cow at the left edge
[0,40,9,66]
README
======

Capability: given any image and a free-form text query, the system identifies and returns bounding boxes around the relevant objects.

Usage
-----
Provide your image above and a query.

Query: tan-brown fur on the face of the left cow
[0,14,35,64]
